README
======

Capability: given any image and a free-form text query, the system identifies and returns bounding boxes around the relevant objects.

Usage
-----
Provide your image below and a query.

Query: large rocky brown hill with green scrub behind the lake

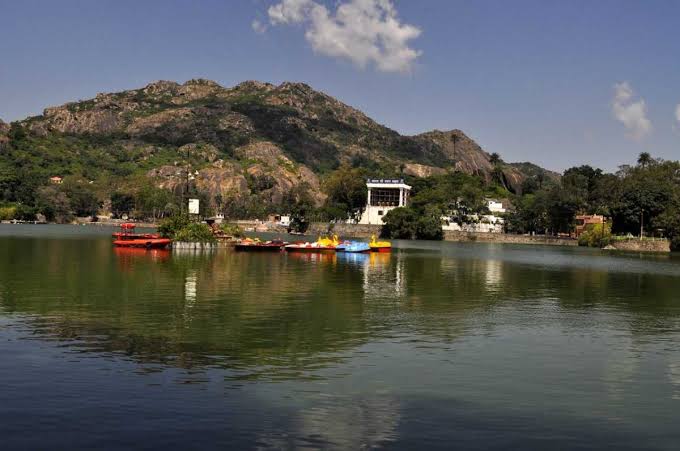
[0,80,556,210]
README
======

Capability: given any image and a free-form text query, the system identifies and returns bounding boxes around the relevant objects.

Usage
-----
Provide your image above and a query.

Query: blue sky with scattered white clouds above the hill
[0,0,680,171]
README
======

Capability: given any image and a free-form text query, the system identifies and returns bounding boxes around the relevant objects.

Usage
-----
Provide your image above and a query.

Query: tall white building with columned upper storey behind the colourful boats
[359,179,411,225]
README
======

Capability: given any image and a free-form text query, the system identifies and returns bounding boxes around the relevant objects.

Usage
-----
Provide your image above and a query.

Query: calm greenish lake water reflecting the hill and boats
[0,225,680,450]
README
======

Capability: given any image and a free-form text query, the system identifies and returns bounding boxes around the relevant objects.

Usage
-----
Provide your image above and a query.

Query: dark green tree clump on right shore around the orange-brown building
[507,157,680,250]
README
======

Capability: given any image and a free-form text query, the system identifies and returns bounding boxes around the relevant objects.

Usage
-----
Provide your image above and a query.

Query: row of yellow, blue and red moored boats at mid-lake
[235,236,392,254]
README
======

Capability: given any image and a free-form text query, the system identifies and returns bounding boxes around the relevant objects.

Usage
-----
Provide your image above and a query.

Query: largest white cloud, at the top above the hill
[267,0,421,72]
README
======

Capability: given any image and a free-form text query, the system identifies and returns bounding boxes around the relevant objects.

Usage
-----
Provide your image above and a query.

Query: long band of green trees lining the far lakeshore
[0,153,680,250]
